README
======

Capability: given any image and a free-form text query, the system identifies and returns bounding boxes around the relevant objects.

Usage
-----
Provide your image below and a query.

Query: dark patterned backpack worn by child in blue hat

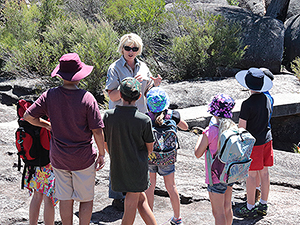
[148,110,179,165]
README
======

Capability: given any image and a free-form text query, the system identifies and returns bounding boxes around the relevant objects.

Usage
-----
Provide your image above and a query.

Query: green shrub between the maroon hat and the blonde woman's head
[69,20,119,94]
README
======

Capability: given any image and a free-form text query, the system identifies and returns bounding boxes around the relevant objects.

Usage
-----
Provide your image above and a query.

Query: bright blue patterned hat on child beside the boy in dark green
[146,87,170,113]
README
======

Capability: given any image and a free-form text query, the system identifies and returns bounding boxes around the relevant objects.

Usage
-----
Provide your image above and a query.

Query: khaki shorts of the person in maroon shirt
[53,163,96,202]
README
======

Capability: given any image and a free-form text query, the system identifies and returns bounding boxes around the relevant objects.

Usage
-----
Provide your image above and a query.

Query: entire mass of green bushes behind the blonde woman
[0,0,245,94]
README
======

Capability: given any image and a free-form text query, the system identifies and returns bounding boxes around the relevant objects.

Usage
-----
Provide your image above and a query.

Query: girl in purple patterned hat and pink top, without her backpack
[195,94,236,225]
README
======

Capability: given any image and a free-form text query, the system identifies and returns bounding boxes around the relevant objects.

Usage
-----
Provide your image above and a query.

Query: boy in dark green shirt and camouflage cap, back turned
[103,77,157,225]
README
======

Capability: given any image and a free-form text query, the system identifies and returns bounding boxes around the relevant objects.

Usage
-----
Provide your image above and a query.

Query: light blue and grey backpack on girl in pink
[206,128,255,185]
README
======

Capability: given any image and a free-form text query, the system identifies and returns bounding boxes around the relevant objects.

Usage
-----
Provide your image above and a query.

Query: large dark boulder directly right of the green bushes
[166,2,284,74]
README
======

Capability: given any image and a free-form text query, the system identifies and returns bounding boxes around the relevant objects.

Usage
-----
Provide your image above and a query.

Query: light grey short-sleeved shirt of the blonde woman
[105,56,153,113]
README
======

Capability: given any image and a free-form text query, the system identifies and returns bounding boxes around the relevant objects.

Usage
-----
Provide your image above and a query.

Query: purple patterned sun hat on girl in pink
[208,94,235,118]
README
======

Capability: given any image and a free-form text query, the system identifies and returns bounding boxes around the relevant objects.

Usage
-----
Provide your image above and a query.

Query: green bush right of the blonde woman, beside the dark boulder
[161,2,245,80]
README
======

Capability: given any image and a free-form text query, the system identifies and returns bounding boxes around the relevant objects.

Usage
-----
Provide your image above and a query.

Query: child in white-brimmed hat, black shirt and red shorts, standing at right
[235,68,274,217]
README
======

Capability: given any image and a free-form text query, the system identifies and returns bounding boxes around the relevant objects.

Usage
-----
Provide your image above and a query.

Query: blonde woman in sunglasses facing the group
[105,33,162,211]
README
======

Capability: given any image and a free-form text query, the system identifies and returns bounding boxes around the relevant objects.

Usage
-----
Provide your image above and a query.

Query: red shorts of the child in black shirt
[249,141,274,171]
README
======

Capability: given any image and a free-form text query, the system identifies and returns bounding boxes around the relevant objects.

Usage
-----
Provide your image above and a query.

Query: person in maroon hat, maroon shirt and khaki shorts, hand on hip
[24,53,105,224]
